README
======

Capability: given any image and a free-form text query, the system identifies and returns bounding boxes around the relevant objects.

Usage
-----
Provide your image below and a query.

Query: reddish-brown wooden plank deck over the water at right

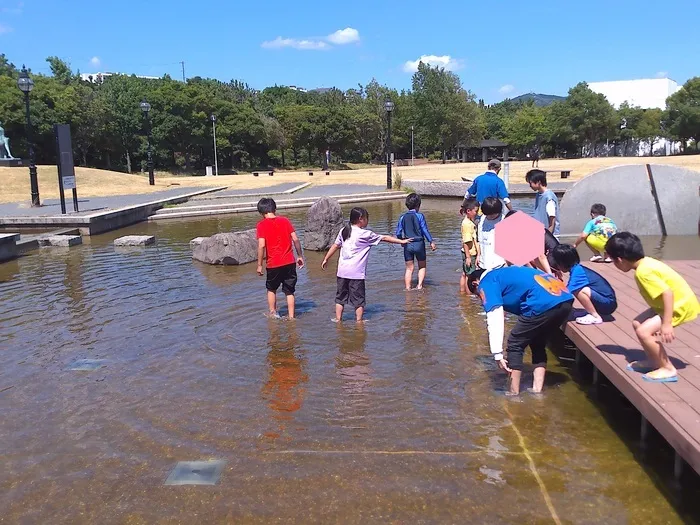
[565,261,700,476]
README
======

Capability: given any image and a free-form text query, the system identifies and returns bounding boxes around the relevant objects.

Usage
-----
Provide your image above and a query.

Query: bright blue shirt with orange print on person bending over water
[479,266,574,317]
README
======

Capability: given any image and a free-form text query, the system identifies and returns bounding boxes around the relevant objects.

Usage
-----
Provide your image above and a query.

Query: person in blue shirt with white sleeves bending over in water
[467,266,574,396]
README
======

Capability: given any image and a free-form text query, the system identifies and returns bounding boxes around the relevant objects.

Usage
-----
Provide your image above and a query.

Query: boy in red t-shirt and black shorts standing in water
[257,198,304,319]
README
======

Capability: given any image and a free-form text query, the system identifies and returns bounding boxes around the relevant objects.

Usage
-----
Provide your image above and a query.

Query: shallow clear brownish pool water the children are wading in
[0,200,700,524]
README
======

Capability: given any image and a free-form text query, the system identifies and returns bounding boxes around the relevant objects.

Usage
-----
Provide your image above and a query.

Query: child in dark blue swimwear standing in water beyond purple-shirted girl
[396,193,437,290]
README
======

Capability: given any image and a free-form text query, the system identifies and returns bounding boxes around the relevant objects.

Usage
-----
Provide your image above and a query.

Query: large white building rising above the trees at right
[588,78,680,109]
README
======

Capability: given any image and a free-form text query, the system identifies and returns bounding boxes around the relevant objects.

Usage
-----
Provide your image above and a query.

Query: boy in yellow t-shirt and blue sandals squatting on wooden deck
[605,232,700,383]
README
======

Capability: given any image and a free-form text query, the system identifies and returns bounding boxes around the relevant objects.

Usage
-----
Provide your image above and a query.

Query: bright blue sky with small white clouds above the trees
[0,0,700,103]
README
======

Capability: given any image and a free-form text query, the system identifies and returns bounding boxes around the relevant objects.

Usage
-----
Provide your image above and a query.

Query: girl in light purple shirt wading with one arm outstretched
[321,208,412,323]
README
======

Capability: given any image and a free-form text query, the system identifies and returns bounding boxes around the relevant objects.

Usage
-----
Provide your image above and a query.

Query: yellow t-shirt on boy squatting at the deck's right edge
[634,257,700,326]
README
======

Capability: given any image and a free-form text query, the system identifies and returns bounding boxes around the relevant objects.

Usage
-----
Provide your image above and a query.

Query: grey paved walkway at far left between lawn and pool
[0,186,216,217]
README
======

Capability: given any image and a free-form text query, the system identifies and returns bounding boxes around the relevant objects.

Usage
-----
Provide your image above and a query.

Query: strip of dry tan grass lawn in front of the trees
[0,155,700,202]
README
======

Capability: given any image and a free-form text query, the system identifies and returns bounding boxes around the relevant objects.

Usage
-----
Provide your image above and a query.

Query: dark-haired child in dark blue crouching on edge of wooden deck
[552,244,617,325]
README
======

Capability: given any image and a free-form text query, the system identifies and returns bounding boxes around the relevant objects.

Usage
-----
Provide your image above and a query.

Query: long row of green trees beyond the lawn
[0,54,700,173]
